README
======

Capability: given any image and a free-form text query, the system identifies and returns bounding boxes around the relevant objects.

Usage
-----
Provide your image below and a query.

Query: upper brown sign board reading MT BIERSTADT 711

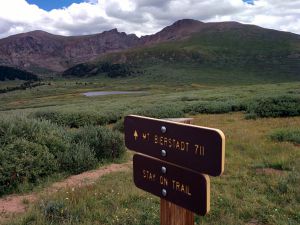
[124,115,225,176]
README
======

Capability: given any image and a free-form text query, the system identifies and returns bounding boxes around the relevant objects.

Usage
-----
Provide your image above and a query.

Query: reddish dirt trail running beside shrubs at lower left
[0,162,131,224]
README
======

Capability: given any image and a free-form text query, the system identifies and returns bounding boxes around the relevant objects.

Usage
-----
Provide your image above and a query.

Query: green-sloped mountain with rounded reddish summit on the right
[64,20,300,81]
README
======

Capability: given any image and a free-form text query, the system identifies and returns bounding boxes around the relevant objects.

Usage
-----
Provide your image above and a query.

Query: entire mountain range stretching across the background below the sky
[0,19,300,79]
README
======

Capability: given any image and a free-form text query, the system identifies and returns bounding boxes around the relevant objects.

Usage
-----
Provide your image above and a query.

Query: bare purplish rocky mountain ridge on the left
[0,29,139,72]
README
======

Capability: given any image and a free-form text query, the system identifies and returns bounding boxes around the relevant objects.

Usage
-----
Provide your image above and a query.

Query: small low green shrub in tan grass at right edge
[270,128,300,144]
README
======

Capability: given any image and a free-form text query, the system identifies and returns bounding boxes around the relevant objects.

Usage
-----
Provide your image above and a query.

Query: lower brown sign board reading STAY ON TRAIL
[133,154,210,215]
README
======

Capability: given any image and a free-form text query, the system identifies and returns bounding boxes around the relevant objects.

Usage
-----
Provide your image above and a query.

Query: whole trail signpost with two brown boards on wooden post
[124,115,225,225]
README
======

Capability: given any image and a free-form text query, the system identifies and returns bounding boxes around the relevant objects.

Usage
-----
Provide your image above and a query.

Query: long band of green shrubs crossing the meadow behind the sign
[28,91,300,125]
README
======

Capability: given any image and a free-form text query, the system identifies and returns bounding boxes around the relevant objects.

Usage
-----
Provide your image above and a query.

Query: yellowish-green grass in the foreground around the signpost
[8,113,300,225]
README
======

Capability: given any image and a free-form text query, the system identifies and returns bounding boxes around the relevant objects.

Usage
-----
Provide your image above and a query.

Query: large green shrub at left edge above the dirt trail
[0,116,71,195]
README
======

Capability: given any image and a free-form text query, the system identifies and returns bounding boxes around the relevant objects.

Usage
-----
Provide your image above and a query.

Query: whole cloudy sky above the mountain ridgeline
[0,0,300,38]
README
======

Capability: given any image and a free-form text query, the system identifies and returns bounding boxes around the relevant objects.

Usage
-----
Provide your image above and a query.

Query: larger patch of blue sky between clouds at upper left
[26,0,84,11]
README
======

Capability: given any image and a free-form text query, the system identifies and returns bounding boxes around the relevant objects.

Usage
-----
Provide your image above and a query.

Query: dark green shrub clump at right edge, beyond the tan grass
[247,96,300,117]
